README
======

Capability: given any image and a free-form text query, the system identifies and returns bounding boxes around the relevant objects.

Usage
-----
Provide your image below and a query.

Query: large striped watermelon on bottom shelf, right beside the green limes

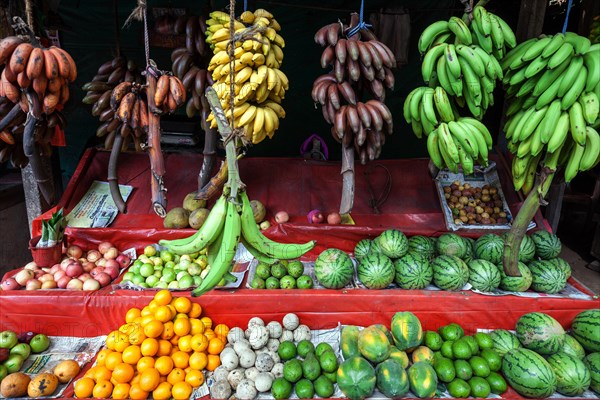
[502,348,556,398]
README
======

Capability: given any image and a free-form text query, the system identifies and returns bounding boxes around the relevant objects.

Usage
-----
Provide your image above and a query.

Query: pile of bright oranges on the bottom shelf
[74,290,229,400]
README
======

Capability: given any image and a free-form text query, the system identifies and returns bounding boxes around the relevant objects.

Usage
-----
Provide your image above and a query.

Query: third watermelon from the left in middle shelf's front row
[394,251,433,290]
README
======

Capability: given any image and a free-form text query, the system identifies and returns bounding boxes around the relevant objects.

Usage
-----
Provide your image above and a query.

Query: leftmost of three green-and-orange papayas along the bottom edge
[337,356,377,400]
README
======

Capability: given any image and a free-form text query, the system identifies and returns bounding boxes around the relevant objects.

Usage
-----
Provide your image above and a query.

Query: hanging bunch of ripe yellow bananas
[206,8,289,144]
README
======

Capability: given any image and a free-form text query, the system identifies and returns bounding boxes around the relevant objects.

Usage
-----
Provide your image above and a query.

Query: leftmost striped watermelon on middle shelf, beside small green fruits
[315,249,354,289]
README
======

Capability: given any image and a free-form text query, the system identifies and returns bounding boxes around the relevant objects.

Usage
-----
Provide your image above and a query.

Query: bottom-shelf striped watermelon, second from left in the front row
[546,353,592,396]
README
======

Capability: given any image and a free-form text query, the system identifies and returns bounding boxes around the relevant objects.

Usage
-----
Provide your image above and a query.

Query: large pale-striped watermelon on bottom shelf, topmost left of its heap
[515,312,565,355]
